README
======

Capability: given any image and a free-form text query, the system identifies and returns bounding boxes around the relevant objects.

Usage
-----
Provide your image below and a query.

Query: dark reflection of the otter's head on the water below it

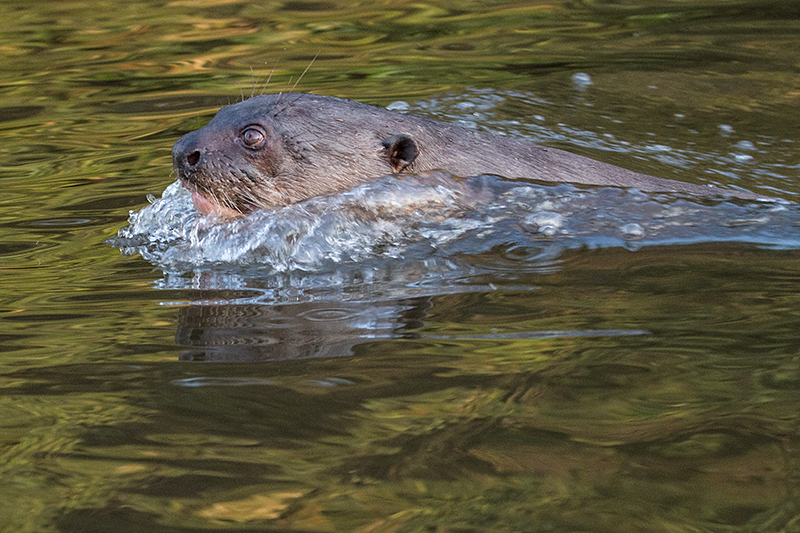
[175,297,431,362]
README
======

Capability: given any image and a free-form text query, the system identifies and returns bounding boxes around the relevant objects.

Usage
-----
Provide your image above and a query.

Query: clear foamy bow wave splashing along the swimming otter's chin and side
[110,173,800,274]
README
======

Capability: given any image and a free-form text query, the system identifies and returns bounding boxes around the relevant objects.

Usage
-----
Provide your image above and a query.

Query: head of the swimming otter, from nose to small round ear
[172,94,419,218]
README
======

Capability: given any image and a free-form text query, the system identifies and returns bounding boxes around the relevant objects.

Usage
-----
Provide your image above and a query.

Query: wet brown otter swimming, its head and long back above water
[172,93,764,218]
